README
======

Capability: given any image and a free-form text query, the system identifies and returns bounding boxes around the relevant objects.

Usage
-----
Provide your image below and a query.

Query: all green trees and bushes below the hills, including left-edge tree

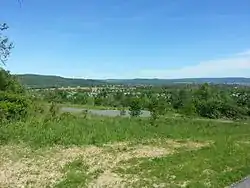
[0,24,250,122]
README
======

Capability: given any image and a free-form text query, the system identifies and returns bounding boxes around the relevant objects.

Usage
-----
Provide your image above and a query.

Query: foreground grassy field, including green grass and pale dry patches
[0,115,250,188]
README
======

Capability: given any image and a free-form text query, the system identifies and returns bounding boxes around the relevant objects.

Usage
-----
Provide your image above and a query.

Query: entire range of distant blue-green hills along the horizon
[17,74,250,88]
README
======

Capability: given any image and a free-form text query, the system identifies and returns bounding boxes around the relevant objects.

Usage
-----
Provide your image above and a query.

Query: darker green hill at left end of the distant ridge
[16,74,106,88]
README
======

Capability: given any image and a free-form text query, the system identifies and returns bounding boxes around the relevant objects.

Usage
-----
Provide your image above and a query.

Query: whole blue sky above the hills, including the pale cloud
[0,0,250,79]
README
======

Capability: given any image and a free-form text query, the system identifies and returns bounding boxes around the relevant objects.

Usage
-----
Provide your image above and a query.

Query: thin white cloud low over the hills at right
[139,50,250,78]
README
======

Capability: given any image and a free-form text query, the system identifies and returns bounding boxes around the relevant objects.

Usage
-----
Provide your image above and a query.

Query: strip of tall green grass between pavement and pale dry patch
[0,114,250,147]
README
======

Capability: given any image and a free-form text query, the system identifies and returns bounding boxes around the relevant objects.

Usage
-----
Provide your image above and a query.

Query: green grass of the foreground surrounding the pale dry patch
[0,108,250,187]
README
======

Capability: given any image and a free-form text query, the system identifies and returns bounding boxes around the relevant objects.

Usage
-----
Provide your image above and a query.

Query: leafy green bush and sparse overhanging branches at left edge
[0,24,30,121]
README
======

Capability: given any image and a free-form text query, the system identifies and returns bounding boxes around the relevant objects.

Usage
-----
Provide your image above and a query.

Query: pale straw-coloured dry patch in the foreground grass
[0,140,210,188]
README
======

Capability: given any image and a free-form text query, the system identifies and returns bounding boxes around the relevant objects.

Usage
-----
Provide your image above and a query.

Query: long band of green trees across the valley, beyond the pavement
[35,84,250,119]
